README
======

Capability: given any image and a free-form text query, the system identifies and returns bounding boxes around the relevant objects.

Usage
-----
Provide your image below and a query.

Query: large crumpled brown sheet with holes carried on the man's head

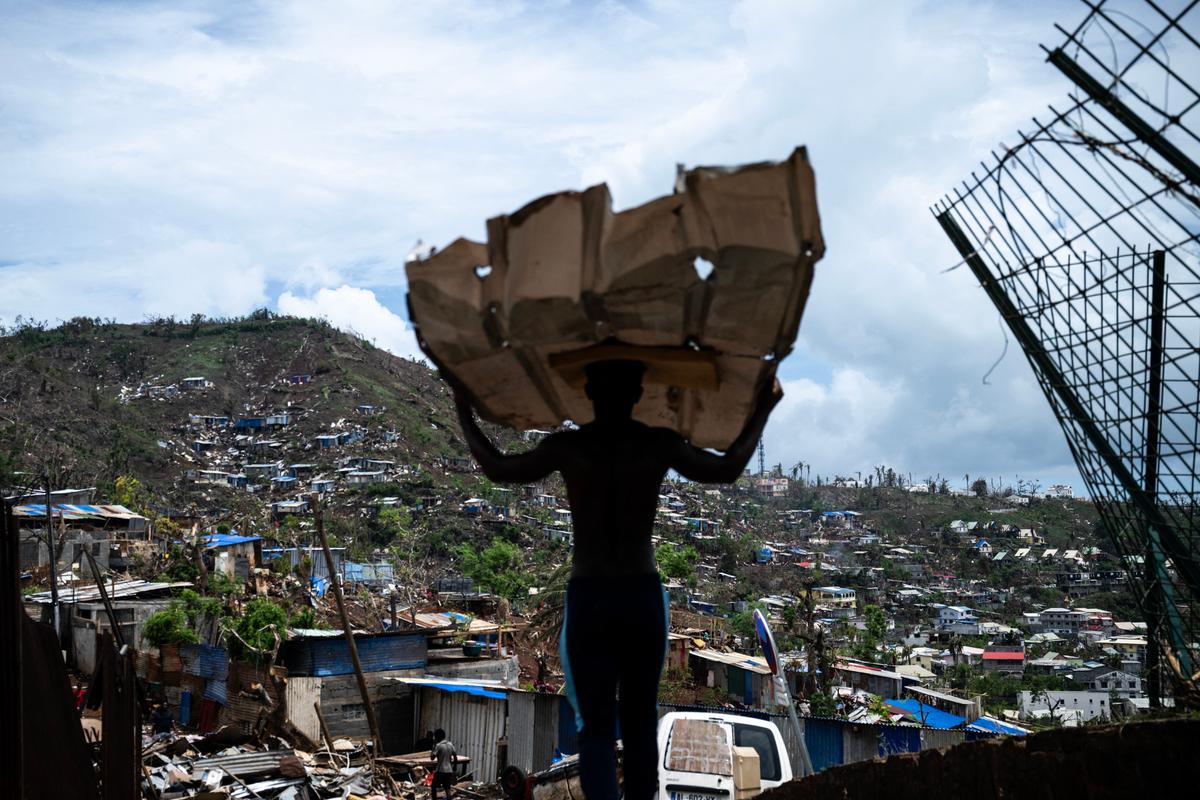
[408,148,824,450]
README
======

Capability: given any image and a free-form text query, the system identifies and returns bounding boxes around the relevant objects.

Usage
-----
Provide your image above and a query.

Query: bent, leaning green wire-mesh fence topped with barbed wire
[934,0,1200,705]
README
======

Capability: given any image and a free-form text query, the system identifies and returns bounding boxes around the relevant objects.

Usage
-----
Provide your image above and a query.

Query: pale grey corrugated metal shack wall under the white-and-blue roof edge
[418,686,508,782]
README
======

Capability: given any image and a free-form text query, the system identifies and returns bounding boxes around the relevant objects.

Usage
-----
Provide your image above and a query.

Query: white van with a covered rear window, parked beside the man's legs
[659,711,792,800]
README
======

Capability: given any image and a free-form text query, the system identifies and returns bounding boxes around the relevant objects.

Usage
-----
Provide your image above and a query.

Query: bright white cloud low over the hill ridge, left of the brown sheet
[277,285,424,359]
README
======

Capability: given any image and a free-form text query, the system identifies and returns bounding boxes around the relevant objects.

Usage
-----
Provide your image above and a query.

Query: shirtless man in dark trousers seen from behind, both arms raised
[450,361,782,800]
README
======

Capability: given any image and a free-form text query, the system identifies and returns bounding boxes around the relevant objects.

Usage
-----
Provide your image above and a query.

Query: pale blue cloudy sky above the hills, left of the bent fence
[0,0,1084,488]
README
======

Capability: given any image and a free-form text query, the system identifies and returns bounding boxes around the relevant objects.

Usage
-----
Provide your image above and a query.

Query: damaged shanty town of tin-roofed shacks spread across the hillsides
[5,357,1172,798]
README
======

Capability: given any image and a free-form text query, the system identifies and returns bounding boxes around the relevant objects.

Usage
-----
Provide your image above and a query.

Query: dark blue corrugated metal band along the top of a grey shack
[283,632,428,675]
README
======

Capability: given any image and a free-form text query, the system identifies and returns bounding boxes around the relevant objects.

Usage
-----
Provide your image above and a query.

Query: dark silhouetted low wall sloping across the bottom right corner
[761,720,1200,800]
